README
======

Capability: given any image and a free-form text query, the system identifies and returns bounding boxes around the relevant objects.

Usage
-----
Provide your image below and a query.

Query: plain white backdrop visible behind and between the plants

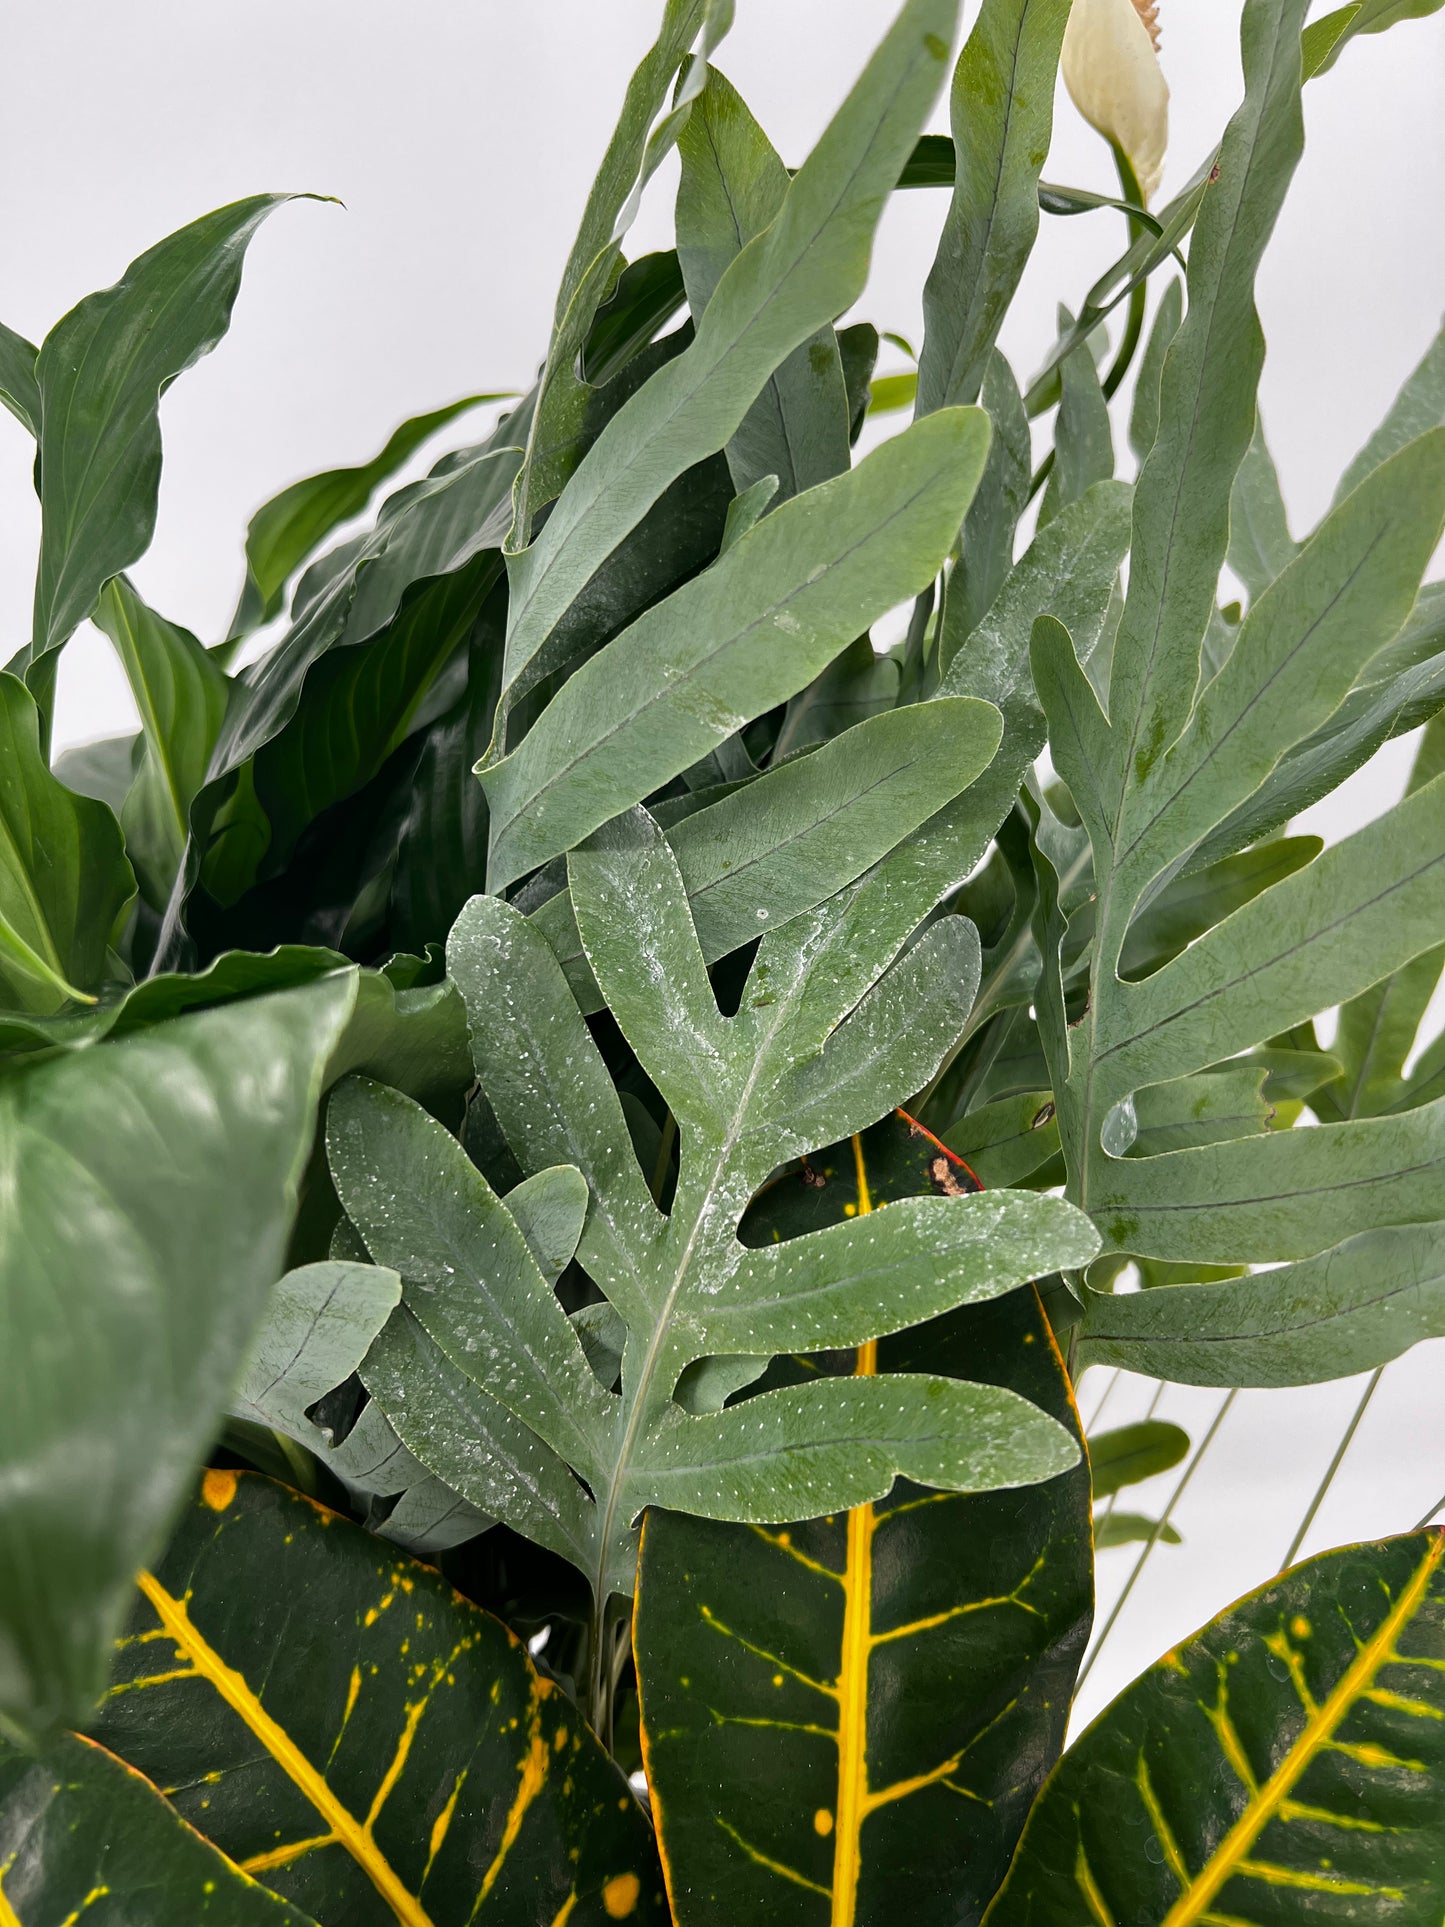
[0,0,1445,1734]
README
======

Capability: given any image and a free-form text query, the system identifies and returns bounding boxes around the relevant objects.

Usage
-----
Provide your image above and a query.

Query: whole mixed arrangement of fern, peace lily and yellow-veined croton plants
[0,0,1445,1927]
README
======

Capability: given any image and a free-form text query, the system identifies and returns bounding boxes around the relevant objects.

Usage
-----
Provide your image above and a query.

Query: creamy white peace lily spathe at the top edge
[1062,0,1169,202]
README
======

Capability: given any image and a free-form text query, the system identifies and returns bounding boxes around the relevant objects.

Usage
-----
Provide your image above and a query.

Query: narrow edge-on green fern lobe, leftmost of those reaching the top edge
[516,0,732,545]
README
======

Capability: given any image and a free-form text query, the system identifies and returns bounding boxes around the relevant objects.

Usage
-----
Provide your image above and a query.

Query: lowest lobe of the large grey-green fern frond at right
[1081,1222,1445,1386]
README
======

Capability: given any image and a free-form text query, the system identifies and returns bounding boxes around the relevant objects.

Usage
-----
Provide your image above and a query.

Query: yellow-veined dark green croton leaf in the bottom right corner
[986,1532,1445,1927]
